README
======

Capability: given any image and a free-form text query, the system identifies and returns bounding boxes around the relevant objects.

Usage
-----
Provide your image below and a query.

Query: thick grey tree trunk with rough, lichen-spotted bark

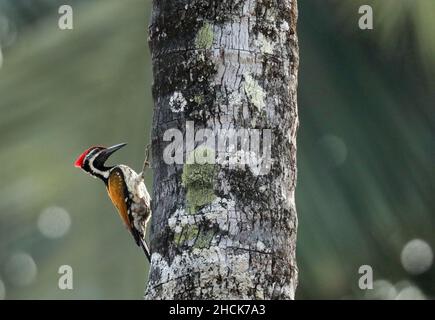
[145,0,299,299]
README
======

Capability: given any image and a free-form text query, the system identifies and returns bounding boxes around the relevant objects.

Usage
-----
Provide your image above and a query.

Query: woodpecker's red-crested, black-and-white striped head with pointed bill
[74,143,126,181]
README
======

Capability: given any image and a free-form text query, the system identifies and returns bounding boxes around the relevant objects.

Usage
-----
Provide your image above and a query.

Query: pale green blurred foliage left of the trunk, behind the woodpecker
[0,0,152,299]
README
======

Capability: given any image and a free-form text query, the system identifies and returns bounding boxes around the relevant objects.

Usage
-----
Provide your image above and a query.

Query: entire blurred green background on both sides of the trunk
[0,0,435,299]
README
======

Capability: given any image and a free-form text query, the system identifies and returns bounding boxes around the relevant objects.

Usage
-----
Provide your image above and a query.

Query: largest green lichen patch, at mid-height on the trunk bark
[181,146,216,214]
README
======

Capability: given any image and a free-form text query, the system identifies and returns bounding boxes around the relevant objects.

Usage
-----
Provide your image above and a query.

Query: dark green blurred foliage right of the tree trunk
[296,0,435,298]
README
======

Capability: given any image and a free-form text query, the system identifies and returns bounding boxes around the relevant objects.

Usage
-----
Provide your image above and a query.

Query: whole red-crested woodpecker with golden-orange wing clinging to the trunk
[74,143,151,261]
